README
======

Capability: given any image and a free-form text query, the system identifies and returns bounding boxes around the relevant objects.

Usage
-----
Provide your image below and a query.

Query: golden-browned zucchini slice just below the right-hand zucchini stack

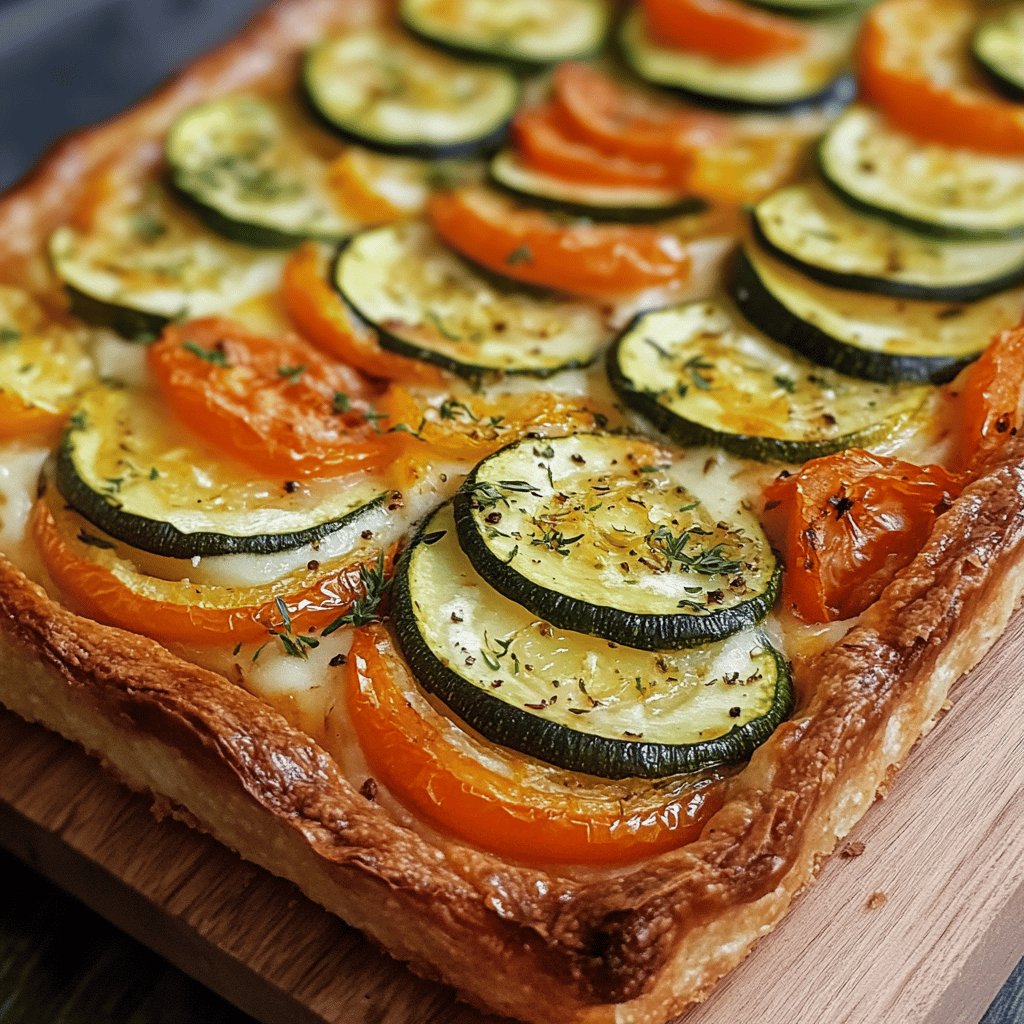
[608,301,928,463]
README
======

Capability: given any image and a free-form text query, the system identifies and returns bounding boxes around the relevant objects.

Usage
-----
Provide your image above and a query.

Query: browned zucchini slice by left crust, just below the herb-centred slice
[49,193,283,341]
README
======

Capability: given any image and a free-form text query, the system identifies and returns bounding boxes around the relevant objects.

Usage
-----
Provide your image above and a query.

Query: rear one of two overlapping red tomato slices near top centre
[553,61,731,162]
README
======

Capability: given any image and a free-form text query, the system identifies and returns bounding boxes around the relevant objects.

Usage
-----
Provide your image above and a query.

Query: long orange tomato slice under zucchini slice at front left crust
[31,500,392,644]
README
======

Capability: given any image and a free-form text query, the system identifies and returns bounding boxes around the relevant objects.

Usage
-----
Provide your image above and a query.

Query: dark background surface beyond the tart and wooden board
[0,0,1024,1024]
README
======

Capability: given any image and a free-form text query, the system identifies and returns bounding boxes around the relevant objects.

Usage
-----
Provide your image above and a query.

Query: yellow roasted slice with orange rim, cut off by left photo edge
[0,286,96,438]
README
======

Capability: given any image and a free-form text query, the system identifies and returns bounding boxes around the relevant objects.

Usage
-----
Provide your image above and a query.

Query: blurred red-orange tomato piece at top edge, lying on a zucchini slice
[643,0,810,61]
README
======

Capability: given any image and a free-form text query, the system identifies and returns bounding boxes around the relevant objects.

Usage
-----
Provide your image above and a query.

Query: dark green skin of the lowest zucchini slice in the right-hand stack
[730,252,983,384]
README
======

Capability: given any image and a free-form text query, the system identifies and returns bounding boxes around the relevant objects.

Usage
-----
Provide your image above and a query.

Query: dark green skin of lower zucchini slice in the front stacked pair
[392,501,795,778]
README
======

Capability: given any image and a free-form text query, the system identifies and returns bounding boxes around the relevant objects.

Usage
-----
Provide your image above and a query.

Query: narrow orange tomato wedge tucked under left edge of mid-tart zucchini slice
[282,243,443,385]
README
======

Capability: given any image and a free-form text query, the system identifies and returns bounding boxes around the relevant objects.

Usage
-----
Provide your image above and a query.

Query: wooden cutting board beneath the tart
[0,614,1024,1024]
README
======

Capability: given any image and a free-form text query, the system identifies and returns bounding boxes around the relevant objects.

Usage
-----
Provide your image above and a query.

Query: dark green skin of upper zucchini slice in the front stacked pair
[452,434,782,651]
